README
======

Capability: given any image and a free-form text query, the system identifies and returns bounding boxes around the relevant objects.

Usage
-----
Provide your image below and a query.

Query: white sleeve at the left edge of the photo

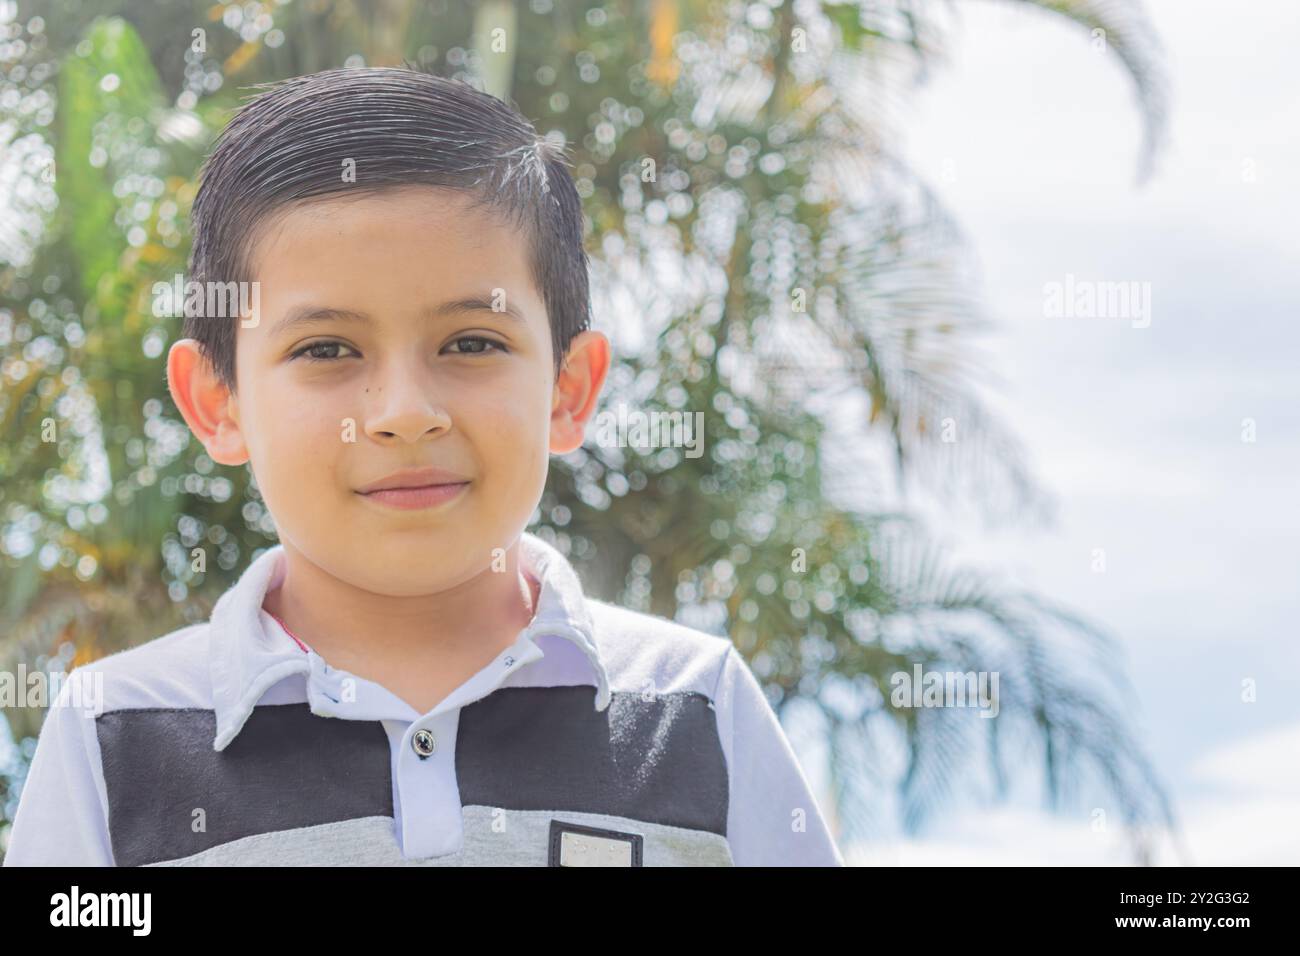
[4,669,114,866]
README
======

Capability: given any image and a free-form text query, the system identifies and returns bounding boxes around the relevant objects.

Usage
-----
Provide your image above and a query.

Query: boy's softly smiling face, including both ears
[169,186,608,597]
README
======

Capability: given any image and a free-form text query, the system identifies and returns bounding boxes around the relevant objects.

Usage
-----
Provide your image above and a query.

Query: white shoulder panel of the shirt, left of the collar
[68,622,212,711]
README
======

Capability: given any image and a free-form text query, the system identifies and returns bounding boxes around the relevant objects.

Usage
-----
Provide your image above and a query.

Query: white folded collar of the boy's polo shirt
[209,531,610,750]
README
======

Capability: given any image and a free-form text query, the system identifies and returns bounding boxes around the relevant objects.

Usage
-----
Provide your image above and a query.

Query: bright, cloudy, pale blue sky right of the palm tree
[821,0,1300,865]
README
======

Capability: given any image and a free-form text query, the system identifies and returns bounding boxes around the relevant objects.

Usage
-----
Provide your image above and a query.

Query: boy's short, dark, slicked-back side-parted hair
[185,66,592,390]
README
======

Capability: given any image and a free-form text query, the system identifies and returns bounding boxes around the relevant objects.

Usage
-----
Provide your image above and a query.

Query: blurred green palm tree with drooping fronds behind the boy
[0,0,1173,860]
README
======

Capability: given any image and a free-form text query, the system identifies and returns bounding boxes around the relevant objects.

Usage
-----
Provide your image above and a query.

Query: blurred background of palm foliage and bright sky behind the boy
[0,0,1300,865]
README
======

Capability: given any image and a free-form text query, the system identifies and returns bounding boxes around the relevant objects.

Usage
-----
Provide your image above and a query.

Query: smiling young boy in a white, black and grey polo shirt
[5,69,842,866]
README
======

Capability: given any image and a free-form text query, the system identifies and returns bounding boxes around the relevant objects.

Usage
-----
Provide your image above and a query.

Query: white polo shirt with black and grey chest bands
[4,532,844,866]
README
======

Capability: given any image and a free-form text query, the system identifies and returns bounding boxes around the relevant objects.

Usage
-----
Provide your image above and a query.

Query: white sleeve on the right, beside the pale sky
[714,645,844,866]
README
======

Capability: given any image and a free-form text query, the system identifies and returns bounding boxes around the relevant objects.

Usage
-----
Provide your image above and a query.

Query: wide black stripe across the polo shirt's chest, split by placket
[96,685,728,866]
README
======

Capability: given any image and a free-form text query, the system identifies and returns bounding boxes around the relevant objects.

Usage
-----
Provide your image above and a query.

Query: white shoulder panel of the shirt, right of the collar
[588,598,732,701]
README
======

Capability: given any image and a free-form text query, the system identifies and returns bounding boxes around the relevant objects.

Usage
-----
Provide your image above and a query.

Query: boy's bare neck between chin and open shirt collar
[263,538,541,669]
